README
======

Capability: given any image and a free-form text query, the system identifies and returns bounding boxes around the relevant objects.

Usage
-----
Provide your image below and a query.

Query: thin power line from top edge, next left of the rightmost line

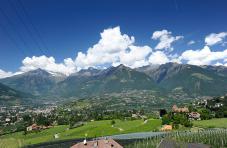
[8,0,44,54]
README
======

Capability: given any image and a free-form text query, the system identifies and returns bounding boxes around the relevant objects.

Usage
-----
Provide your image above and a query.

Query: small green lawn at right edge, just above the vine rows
[193,118,227,128]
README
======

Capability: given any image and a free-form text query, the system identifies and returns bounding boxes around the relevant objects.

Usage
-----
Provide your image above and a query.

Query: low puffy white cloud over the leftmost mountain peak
[20,55,76,75]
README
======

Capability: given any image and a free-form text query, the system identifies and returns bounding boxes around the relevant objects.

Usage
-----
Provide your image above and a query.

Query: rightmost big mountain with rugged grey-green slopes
[137,63,227,96]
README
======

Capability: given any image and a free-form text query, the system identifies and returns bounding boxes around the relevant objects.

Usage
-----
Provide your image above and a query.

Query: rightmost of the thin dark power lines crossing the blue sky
[17,0,49,51]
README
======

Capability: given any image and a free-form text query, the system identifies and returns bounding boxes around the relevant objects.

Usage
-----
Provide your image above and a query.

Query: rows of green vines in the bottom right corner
[125,129,227,148]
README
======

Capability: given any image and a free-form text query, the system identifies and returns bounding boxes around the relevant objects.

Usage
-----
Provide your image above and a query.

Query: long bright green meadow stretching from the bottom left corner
[0,119,161,148]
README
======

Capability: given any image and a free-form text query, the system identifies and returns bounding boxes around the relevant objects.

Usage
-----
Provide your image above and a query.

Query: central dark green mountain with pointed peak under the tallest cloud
[54,65,159,96]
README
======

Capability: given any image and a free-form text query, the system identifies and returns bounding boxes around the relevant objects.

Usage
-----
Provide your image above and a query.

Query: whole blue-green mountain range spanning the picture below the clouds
[0,63,227,103]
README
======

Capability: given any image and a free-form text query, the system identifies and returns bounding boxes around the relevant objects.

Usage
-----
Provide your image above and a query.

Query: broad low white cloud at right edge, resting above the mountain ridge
[179,46,227,65]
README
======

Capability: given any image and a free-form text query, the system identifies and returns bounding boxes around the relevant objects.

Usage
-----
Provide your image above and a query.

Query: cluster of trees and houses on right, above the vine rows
[160,96,227,131]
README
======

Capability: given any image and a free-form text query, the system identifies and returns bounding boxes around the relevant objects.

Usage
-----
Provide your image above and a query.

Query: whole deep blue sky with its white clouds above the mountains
[0,0,227,78]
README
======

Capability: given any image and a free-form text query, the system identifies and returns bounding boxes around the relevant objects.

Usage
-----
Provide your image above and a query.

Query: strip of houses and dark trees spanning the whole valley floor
[0,97,227,138]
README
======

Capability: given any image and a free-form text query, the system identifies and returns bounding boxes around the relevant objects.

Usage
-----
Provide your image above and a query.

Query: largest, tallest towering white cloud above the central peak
[75,26,152,68]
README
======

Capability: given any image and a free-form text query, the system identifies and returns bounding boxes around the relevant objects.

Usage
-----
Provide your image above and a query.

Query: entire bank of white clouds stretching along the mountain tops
[0,26,227,78]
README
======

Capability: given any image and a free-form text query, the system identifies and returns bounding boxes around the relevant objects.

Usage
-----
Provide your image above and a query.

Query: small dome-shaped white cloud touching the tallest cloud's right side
[149,51,170,64]
